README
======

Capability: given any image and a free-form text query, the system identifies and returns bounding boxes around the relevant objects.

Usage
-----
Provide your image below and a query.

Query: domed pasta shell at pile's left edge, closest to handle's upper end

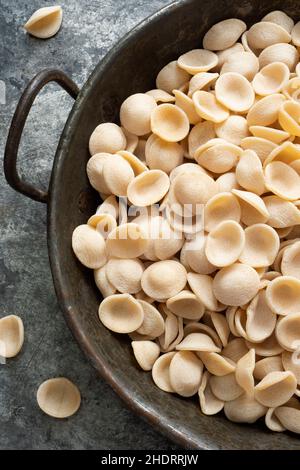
[89,122,127,155]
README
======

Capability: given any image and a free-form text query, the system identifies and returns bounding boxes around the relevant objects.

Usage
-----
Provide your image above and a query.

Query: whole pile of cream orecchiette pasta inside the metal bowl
[72,11,300,433]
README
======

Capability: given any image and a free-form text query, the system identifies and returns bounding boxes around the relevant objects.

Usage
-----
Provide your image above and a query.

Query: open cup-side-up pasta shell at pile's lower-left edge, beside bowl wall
[99,294,144,333]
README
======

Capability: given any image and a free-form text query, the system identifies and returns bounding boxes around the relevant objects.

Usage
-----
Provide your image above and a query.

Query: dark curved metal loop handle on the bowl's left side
[4,69,79,202]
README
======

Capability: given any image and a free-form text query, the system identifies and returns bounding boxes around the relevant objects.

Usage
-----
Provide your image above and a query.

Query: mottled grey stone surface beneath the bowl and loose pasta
[0,0,176,449]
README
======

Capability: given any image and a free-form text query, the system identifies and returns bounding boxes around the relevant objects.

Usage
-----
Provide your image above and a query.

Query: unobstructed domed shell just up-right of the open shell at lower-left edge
[142,260,187,300]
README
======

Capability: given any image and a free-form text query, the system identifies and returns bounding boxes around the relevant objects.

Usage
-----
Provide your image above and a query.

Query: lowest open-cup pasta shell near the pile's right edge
[254,371,297,408]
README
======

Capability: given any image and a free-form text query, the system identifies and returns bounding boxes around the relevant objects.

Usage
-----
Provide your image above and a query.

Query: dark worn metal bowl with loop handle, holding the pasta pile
[5,0,300,449]
